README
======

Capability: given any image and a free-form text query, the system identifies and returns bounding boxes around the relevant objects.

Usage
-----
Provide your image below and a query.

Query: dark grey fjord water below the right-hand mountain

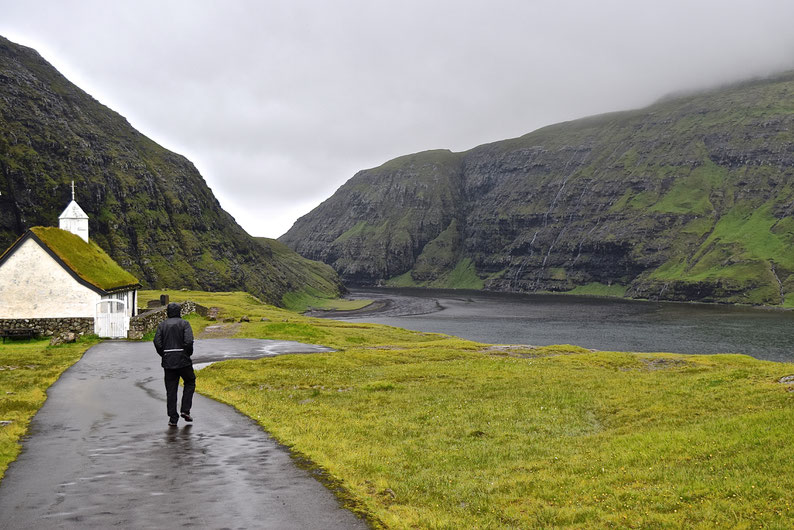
[344,289,794,362]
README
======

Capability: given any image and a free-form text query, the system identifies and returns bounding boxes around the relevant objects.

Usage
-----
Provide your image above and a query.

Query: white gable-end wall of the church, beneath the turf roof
[0,239,100,318]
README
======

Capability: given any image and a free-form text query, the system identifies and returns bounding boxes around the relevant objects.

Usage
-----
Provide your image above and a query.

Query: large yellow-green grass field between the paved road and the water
[184,290,794,528]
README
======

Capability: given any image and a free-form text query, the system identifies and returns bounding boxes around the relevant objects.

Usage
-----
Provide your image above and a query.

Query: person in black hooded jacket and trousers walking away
[154,302,196,427]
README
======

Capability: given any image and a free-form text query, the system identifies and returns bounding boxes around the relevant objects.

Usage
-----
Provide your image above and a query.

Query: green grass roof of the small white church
[30,226,140,291]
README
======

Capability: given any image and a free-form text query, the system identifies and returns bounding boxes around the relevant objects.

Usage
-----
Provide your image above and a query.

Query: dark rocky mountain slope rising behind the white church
[0,37,342,305]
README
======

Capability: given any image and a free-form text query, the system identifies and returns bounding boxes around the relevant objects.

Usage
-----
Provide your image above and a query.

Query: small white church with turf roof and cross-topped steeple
[0,183,141,338]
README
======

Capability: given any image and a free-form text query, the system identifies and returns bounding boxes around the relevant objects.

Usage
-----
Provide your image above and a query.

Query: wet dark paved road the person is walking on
[0,339,367,530]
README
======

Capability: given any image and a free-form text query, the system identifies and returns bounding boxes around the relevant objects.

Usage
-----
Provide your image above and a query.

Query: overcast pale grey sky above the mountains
[0,0,794,237]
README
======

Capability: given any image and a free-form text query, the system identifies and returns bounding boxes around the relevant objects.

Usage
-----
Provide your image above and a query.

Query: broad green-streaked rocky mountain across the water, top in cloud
[280,72,794,305]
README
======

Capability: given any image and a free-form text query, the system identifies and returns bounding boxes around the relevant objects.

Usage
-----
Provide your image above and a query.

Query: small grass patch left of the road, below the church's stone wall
[0,337,98,479]
